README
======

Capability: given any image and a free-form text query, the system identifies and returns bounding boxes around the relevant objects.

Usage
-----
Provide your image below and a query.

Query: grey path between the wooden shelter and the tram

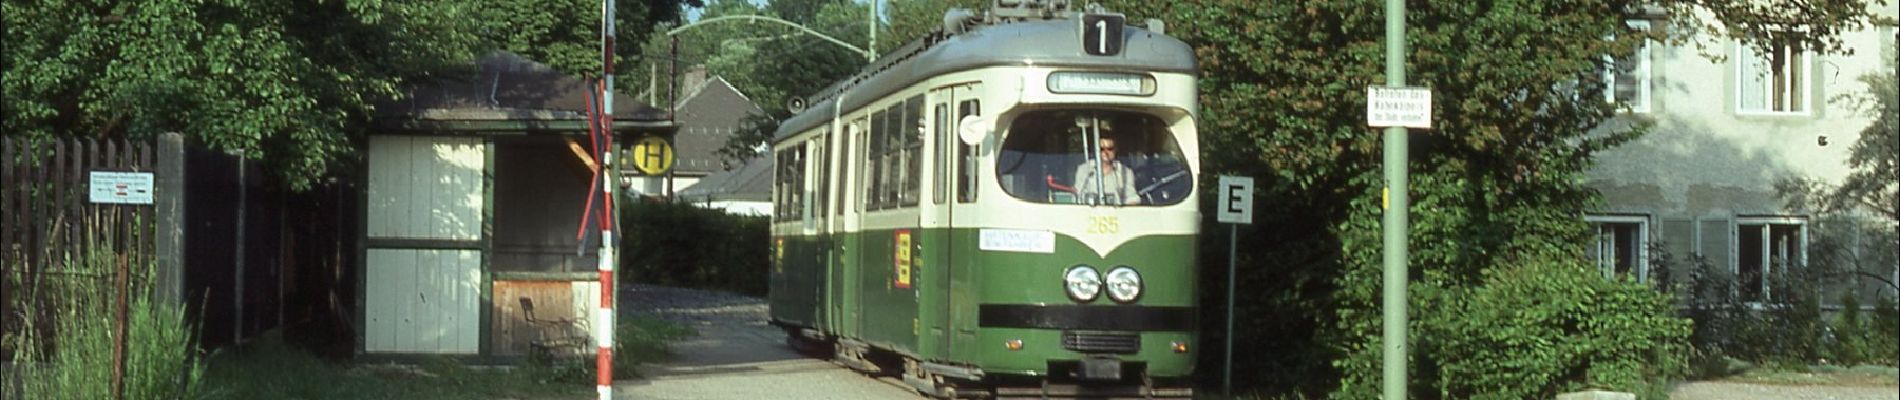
[614,284,920,400]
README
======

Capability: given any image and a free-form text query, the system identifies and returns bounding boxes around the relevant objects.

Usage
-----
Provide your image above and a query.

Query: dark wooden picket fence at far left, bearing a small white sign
[0,135,182,392]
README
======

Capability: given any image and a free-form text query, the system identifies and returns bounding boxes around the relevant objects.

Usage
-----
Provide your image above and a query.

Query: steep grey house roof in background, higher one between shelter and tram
[673,76,766,174]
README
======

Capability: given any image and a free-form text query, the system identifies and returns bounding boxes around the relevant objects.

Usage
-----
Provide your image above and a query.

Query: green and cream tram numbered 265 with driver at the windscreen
[768,2,1199,398]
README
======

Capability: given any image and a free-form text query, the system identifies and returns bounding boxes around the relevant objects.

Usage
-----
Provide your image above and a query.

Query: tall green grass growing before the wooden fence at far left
[0,243,205,400]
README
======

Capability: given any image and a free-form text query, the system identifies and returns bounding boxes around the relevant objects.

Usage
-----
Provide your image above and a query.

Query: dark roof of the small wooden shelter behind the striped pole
[376,51,676,133]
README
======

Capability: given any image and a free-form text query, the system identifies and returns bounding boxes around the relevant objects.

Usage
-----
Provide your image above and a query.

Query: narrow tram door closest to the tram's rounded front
[920,83,982,358]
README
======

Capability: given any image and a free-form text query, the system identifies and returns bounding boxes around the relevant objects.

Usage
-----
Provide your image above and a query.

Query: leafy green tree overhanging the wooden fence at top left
[0,0,483,188]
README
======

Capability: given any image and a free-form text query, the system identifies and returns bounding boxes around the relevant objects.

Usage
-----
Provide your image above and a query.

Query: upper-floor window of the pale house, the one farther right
[1735,32,1813,114]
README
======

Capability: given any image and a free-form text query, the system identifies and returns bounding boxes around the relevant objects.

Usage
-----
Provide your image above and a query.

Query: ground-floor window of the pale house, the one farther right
[1735,218,1807,301]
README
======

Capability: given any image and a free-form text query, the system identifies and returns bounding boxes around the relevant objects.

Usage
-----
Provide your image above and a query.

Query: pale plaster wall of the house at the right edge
[1590,9,1894,301]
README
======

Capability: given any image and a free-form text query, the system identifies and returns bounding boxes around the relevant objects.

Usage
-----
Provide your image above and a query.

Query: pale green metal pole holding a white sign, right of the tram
[1381,0,1410,400]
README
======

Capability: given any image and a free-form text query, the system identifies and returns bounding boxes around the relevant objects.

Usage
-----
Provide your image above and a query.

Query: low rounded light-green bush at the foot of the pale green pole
[1343,260,1689,398]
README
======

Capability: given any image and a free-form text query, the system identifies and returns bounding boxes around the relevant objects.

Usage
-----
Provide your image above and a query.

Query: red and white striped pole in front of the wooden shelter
[593,0,619,400]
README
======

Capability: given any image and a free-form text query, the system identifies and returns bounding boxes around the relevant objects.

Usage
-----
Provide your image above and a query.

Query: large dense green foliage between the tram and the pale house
[1108,0,1875,398]
